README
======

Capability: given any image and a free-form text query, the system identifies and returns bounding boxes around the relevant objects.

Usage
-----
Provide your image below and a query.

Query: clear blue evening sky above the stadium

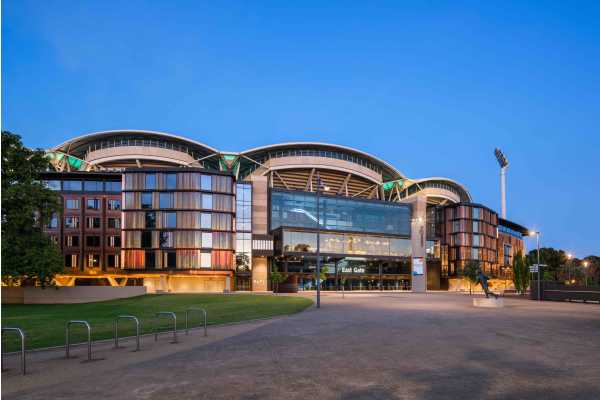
[2,0,600,257]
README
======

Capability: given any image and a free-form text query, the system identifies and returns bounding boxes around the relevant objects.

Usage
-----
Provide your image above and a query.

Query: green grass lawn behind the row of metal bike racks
[2,294,312,352]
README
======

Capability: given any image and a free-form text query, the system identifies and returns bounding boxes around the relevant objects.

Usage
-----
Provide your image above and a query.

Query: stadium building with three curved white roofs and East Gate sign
[43,130,527,292]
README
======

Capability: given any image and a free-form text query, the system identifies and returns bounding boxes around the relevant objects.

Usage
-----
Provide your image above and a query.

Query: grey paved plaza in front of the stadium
[2,293,600,400]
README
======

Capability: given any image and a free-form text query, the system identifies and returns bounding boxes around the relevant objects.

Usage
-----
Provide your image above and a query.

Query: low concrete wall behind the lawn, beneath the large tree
[2,286,146,304]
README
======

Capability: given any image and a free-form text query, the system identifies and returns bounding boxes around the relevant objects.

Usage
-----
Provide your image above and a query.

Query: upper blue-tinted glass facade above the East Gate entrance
[270,190,411,237]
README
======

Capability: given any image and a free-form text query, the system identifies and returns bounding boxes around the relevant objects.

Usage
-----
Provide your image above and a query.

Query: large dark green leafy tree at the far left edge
[2,131,63,286]
